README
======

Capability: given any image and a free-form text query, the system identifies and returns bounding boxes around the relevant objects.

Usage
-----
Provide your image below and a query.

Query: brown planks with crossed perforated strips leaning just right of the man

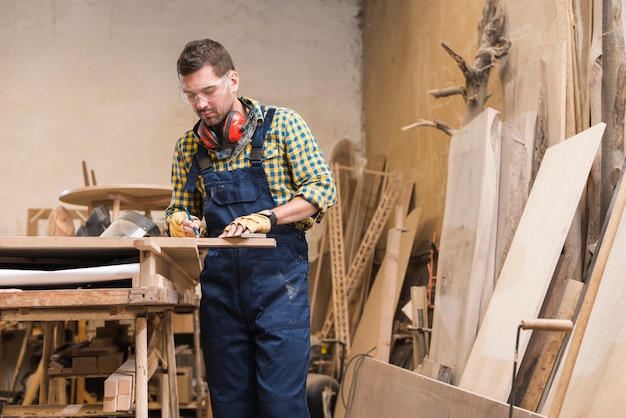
[311,141,404,348]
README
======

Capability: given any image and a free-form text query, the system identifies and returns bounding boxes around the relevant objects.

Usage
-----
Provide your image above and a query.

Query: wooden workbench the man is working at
[0,237,276,418]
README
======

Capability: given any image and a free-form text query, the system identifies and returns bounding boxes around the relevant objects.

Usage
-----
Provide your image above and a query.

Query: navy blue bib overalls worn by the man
[187,108,310,418]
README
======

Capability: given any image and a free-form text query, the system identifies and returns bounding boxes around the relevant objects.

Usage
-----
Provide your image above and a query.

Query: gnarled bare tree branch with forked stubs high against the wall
[402,0,511,135]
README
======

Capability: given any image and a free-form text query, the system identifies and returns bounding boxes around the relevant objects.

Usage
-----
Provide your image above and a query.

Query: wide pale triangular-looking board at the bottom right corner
[559,181,626,417]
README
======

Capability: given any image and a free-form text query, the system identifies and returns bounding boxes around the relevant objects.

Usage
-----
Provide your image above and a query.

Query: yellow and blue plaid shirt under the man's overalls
[165,97,337,237]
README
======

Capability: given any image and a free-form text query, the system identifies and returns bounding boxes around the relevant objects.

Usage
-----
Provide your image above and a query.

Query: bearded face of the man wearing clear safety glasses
[179,65,239,126]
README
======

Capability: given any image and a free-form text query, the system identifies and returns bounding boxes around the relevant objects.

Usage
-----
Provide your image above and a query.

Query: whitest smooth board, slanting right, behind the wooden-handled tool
[459,124,605,400]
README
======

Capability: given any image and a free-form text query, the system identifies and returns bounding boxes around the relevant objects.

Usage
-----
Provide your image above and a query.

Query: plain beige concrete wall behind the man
[0,0,362,242]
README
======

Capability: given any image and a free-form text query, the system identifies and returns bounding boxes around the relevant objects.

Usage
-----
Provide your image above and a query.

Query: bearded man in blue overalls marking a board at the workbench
[165,39,336,418]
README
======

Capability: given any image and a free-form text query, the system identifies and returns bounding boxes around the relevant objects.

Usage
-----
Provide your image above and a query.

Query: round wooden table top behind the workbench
[59,184,172,210]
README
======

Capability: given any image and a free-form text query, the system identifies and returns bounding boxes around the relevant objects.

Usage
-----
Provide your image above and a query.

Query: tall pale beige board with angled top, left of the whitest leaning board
[428,109,501,384]
